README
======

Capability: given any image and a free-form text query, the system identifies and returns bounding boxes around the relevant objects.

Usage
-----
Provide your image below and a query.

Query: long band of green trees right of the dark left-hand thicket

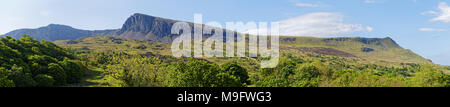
[81,52,450,87]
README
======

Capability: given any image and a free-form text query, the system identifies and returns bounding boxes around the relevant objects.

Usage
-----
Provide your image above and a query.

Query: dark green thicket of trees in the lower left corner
[0,35,85,87]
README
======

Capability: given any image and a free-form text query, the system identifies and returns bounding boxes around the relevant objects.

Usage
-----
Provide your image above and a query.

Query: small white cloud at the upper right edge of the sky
[429,2,450,23]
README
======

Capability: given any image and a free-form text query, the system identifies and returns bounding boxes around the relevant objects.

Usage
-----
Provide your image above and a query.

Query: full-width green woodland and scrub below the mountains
[0,36,450,87]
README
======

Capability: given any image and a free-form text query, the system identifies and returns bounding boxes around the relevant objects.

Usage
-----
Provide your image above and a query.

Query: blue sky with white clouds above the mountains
[0,0,450,65]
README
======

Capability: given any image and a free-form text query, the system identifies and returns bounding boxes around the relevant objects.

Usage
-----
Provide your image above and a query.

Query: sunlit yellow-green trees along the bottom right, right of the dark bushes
[252,58,450,87]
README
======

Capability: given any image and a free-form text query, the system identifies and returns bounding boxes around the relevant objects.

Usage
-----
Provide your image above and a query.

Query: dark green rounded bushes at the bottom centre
[170,60,248,87]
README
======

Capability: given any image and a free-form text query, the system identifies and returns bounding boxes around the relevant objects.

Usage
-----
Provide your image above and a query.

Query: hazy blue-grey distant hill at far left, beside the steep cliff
[4,24,117,41]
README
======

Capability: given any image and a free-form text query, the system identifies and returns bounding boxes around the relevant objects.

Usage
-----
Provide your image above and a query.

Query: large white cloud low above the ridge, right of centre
[245,12,373,37]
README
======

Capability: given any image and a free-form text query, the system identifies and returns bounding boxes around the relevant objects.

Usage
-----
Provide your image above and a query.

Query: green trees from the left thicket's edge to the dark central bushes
[89,52,250,87]
